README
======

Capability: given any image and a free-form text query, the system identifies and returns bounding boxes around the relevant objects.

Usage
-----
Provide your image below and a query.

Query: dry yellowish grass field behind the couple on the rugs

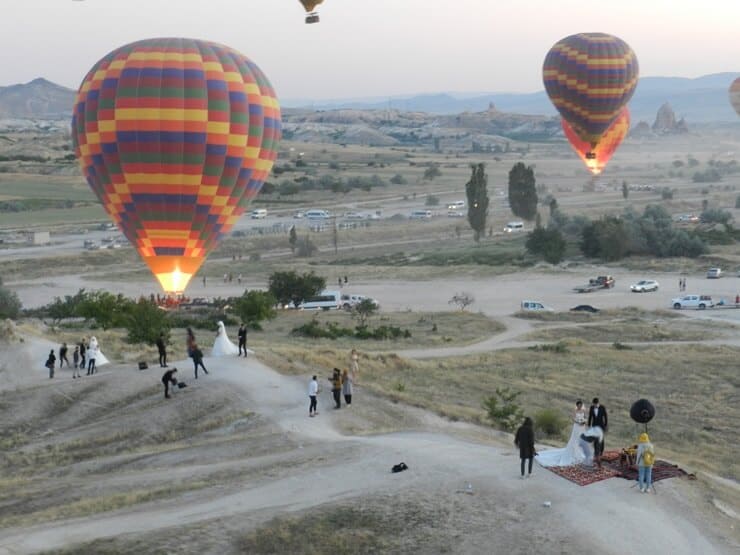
[267,341,740,479]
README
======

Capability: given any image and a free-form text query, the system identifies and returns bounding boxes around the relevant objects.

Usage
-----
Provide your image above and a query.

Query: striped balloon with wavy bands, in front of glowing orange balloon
[542,33,639,158]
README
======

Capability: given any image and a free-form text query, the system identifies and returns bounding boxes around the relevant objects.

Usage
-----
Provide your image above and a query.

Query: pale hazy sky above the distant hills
[0,0,740,101]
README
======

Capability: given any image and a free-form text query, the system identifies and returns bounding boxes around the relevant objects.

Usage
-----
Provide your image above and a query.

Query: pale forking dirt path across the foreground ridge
[0,357,731,555]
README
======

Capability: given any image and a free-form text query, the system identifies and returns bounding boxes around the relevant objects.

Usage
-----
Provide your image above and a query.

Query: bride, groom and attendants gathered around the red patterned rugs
[514,397,655,493]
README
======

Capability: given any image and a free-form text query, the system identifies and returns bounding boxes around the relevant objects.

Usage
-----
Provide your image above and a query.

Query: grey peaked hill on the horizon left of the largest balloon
[0,78,75,119]
